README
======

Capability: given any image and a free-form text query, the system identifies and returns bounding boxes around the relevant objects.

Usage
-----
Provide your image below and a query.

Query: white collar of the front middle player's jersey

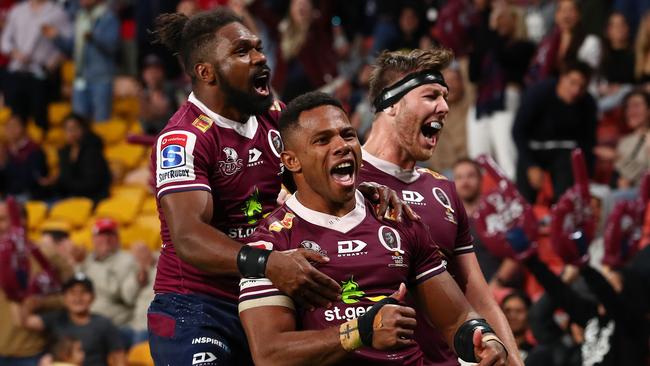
[285,191,366,234]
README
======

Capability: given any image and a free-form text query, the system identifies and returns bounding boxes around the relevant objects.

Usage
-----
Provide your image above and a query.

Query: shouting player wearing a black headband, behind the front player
[360,48,523,365]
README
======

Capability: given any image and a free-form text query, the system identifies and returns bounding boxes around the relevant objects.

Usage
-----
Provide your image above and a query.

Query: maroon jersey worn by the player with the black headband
[360,150,474,365]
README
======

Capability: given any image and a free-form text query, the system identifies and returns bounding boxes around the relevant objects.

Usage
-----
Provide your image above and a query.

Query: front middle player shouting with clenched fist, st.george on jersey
[239,92,507,365]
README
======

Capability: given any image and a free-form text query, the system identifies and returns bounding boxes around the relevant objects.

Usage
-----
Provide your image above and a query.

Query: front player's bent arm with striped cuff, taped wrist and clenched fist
[239,279,416,365]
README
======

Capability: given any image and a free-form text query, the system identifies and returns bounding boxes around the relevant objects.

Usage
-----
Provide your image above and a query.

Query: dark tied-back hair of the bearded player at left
[154,7,243,80]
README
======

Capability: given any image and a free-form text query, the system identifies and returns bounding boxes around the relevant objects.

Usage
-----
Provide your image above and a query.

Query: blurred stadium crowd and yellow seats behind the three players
[0,0,650,366]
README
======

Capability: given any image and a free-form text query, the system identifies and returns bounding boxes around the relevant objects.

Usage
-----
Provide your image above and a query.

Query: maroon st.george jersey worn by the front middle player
[239,191,445,366]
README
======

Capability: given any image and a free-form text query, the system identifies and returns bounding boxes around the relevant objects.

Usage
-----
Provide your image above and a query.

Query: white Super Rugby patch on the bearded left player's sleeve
[156,131,196,187]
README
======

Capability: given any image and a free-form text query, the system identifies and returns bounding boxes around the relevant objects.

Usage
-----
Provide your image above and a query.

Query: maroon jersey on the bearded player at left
[151,94,282,301]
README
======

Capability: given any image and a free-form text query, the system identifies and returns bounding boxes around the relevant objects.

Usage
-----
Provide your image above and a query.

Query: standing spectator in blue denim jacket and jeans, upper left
[43,0,120,122]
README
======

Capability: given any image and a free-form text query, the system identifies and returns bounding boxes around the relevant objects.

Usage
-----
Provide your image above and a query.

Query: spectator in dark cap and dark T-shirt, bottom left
[16,273,126,366]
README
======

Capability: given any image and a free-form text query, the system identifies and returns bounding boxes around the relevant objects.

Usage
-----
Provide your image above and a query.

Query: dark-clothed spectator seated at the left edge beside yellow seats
[0,115,48,201]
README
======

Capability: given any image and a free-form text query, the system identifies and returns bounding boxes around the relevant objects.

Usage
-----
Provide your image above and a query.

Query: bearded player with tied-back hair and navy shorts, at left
[148,8,408,366]
